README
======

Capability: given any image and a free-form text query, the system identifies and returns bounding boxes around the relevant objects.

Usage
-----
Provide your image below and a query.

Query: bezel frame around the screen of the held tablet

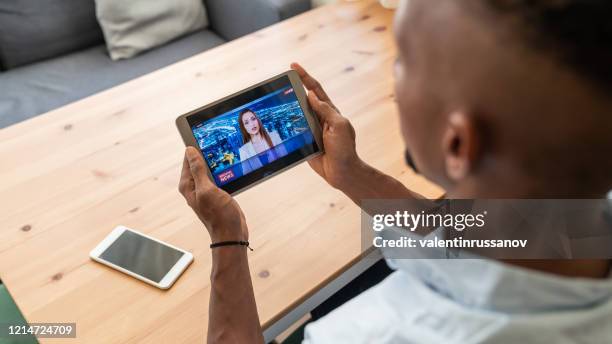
[176,70,324,195]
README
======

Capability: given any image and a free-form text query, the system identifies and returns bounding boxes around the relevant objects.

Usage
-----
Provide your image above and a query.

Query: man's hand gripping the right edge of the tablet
[291,63,362,190]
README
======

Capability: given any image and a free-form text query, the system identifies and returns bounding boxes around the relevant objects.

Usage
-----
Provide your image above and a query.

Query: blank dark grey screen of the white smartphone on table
[100,230,184,283]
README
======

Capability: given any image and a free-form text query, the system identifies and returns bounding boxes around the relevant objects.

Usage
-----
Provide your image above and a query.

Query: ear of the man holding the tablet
[442,111,479,181]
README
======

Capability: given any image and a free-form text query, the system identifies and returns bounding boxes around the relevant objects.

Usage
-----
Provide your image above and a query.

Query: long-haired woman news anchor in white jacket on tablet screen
[238,109,287,174]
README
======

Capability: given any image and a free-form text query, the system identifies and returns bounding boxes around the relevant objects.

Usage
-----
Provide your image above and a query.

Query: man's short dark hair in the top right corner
[482,0,612,92]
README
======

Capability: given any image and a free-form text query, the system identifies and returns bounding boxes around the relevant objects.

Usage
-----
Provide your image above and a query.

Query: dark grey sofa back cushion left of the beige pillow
[0,0,103,69]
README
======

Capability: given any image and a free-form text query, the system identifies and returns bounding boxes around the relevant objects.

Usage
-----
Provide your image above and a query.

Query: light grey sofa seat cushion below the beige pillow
[0,30,224,128]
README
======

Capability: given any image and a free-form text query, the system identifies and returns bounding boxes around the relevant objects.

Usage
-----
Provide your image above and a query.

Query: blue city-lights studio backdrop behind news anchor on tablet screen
[193,87,312,174]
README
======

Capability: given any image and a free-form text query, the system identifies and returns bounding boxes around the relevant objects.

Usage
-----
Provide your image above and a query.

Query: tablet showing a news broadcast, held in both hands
[176,71,323,195]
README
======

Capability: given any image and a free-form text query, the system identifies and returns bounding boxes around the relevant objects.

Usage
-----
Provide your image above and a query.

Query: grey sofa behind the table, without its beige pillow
[0,0,311,128]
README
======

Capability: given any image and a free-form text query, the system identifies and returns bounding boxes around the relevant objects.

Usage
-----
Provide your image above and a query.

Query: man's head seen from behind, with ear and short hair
[395,0,612,198]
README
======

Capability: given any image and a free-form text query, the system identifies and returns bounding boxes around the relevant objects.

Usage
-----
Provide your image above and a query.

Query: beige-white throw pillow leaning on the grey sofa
[95,0,208,60]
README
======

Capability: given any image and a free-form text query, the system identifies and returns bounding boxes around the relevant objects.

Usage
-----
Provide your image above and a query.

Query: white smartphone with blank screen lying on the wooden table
[89,226,193,289]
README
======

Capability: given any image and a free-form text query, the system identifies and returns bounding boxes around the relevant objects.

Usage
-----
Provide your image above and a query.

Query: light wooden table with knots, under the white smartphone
[0,0,441,343]
